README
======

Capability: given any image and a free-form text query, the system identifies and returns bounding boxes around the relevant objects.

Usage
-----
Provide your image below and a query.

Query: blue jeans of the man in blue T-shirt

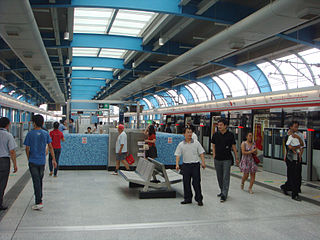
[29,162,44,204]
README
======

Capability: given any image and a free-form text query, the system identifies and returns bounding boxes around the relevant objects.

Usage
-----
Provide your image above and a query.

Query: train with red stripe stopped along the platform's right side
[125,90,320,180]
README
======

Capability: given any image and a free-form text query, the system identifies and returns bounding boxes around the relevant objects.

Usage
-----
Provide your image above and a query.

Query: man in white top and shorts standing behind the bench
[112,124,130,175]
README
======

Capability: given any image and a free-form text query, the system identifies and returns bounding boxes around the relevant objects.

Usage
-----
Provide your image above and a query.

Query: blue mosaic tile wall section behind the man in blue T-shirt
[59,134,109,166]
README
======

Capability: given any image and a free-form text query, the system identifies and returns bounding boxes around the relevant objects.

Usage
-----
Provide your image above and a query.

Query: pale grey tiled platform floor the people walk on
[0,154,320,240]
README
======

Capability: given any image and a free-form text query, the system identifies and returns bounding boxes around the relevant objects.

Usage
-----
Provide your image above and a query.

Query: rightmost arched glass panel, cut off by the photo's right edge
[299,48,320,85]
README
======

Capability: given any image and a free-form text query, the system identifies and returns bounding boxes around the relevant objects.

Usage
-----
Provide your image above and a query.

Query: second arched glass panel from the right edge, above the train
[272,55,313,89]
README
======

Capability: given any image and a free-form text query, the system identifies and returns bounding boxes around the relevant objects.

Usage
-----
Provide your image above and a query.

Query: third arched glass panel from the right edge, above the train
[257,62,286,92]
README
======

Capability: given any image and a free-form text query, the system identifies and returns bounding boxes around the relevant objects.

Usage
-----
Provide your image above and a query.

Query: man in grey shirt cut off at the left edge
[0,117,18,211]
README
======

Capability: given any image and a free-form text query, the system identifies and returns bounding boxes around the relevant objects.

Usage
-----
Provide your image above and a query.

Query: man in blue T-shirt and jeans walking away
[24,115,57,210]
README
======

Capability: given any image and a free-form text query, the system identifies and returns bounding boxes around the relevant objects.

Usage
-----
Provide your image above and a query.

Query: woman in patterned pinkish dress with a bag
[239,132,258,194]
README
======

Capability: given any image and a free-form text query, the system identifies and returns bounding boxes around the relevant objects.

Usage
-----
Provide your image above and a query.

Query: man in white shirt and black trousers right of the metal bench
[174,128,206,206]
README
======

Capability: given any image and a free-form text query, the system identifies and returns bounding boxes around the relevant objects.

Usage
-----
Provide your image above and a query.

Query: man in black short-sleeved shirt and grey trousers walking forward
[211,119,239,202]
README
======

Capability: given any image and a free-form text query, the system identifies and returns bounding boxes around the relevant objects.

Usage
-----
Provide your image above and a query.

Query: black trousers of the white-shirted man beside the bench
[182,163,203,202]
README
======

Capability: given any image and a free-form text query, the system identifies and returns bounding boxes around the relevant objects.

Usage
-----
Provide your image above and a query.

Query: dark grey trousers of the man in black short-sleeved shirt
[214,159,232,197]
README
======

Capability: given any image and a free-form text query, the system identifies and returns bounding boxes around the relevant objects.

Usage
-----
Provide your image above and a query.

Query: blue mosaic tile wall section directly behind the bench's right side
[156,132,184,165]
